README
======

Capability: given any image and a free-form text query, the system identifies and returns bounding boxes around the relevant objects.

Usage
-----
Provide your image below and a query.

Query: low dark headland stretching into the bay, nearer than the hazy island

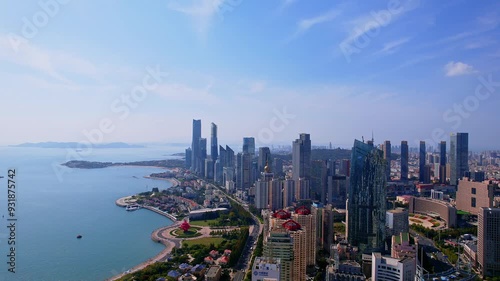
[61,159,184,169]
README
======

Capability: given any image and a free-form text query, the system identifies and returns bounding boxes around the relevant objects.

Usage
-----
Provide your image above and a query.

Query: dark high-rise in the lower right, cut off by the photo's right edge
[477,208,500,277]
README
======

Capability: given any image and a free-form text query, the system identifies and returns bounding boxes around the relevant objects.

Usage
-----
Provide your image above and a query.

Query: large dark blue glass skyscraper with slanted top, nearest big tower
[346,140,387,252]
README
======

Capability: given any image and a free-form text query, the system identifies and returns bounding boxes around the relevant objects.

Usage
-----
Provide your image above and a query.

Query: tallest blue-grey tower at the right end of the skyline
[449,133,469,185]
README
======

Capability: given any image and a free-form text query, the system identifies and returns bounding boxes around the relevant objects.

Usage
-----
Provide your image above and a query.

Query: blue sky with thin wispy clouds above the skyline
[0,0,500,149]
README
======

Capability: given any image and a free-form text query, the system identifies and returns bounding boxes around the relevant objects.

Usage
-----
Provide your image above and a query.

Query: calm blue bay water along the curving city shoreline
[0,147,180,280]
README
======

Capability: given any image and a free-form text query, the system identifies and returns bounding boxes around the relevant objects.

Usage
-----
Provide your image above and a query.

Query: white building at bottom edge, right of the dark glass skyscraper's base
[372,250,415,281]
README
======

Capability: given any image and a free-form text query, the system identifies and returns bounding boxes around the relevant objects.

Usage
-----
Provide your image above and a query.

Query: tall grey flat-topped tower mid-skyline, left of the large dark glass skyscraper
[292,134,311,180]
